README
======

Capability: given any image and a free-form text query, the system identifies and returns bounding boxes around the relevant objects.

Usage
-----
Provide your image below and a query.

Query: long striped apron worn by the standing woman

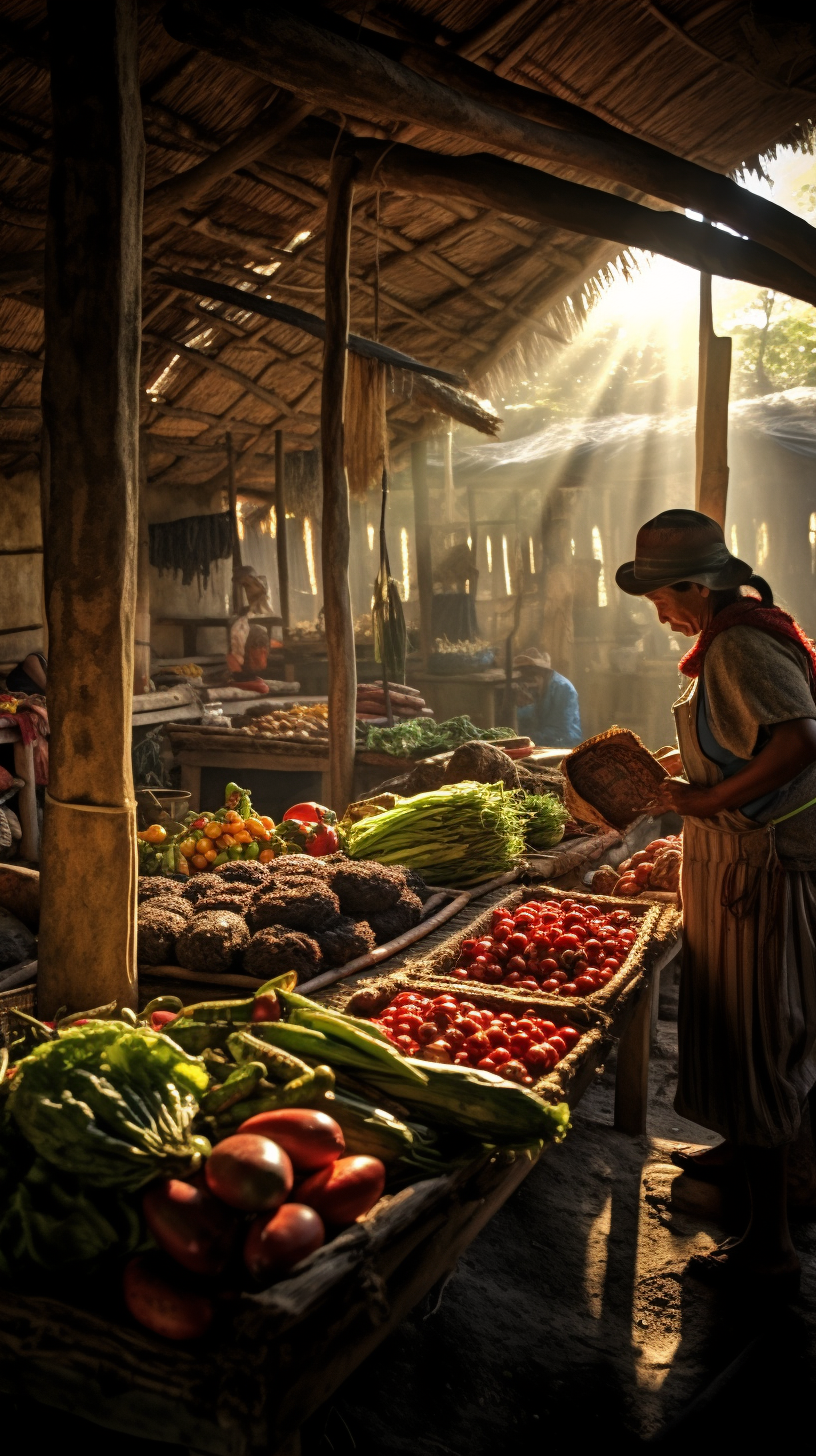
[673,678,816,1147]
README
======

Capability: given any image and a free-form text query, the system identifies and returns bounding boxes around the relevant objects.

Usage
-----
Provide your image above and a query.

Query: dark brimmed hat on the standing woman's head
[615,511,753,597]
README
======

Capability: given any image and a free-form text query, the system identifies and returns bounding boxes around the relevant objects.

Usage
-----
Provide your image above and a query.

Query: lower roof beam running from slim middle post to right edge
[354,141,816,303]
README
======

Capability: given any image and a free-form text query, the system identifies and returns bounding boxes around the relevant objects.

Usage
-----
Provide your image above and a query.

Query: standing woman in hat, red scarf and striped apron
[616,510,816,1290]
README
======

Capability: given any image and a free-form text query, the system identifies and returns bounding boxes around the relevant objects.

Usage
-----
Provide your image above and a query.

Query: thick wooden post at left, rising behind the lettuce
[38,0,144,1016]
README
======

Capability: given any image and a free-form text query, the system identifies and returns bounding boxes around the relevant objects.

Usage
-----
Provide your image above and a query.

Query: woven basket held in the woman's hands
[564,728,669,833]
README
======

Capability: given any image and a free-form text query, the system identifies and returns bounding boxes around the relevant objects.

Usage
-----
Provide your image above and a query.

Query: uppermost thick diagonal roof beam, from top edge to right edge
[163,0,816,281]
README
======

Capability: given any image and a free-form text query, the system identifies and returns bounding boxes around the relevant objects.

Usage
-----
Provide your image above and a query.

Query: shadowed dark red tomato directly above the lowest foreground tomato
[141,1178,238,1274]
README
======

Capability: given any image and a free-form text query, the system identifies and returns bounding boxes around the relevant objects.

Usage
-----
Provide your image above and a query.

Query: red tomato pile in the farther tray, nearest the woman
[450,900,637,996]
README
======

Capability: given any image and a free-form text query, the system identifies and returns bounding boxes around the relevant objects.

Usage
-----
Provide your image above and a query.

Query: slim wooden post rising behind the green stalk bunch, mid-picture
[321,153,357,814]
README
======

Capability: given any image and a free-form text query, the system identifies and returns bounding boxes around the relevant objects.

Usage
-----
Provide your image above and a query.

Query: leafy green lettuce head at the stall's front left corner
[7,1021,210,1188]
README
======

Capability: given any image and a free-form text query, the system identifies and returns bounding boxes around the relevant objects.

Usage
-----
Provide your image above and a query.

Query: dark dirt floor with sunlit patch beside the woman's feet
[4,966,816,1456]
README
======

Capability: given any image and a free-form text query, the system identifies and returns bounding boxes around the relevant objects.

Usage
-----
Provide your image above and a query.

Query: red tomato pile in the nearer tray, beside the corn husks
[370,992,581,1086]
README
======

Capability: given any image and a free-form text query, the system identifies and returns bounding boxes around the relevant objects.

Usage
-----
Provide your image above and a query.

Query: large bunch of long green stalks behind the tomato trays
[347,782,526,885]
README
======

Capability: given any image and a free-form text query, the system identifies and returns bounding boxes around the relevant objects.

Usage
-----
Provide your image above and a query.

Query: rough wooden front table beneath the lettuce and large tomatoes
[0,1144,539,1456]
